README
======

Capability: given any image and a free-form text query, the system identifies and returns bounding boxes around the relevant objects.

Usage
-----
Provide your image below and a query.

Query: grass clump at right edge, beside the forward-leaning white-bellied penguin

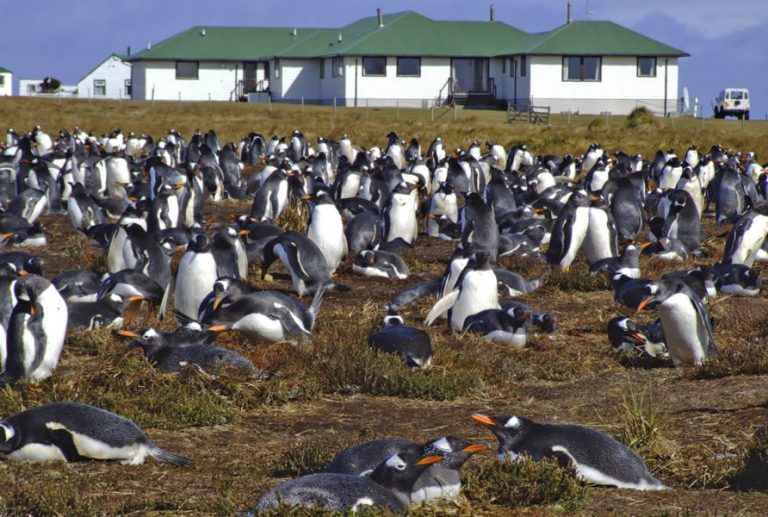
[686,339,768,379]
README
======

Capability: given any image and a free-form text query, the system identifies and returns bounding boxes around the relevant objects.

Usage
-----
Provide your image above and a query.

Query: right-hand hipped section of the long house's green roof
[521,20,690,57]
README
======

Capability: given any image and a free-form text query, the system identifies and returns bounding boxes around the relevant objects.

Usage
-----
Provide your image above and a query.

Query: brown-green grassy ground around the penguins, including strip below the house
[0,98,768,515]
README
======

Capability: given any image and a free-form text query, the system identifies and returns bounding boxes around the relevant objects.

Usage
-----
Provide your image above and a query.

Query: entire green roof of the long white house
[127,11,688,61]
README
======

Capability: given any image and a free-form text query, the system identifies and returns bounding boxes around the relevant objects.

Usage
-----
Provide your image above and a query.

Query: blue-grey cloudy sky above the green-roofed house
[0,0,768,118]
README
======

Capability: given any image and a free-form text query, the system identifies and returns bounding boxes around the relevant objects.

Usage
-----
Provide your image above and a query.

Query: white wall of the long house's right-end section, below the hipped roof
[518,56,678,114]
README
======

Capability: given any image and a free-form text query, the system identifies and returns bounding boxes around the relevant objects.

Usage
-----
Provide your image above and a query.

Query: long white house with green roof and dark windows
[128,11,688,114]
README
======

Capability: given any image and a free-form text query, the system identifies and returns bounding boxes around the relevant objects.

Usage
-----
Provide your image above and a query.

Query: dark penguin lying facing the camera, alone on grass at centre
[368,310,432,368]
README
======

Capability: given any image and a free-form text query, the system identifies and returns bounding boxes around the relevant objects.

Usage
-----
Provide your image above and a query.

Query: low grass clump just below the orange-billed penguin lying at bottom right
[464,457,589,512]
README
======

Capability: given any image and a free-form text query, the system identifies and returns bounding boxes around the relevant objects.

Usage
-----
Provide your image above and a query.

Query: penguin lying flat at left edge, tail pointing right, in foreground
[0,402,191,465]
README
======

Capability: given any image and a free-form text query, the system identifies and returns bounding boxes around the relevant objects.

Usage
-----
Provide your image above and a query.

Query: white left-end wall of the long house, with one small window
[133,61,242,101]
